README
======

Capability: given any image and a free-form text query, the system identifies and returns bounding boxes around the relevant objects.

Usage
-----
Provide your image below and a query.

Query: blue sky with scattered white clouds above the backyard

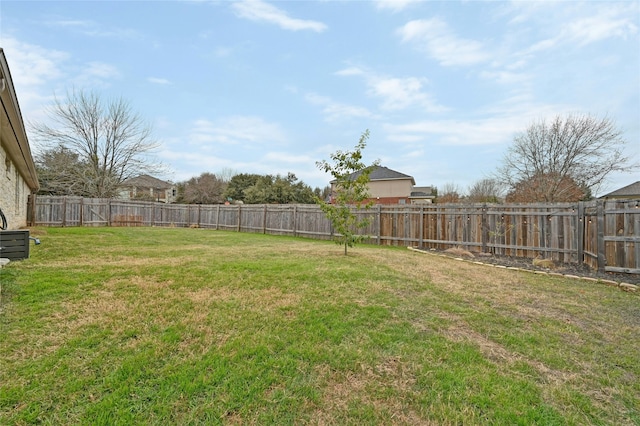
[0,0,640,192]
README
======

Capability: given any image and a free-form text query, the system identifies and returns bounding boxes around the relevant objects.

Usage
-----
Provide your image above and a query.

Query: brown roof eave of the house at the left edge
[0,47,40,192]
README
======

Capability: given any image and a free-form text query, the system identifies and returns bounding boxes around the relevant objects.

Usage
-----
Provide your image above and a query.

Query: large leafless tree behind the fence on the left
[31,90,164,197]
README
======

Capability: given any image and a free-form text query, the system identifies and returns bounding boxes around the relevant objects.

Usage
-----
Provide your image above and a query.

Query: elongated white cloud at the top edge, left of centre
[231,0,327,33]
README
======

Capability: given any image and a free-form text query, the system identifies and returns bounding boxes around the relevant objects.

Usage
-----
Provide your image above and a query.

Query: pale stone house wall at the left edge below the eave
[0,143,31,229]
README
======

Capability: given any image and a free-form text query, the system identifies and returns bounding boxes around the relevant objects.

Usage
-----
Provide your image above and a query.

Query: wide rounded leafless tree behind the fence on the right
[497,114,637,202]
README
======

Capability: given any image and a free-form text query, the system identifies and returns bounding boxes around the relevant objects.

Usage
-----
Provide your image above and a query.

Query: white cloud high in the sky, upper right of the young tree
[397,18,490,66]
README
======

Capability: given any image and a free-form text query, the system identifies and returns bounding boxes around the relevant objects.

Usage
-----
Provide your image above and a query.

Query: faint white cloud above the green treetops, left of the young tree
[189,116,286,146]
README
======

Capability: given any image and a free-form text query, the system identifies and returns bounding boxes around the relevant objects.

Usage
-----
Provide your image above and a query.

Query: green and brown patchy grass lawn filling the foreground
[0,228,640,425]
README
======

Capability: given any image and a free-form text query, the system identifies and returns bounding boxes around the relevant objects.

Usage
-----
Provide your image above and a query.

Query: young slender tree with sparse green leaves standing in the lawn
[316,130,378,256]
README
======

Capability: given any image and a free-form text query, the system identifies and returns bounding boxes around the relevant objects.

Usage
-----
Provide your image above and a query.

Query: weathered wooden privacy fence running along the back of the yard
[29,196,640,273]
